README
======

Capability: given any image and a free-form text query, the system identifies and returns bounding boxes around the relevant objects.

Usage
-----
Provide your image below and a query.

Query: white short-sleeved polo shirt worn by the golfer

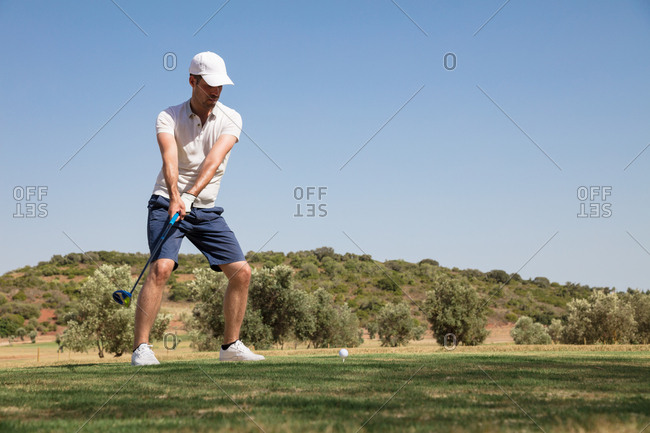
[153,99,242,208]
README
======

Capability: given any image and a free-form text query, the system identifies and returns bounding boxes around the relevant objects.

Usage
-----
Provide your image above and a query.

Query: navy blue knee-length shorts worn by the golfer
[147,194,246,272]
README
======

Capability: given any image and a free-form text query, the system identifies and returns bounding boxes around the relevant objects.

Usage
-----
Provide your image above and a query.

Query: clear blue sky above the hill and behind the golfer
[0,0,650,289]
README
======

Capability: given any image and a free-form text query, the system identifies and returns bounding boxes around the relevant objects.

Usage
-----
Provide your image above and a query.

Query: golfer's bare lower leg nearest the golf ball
[219,261,251,344]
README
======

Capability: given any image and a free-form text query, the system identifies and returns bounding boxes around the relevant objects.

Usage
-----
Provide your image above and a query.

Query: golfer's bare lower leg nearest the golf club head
[133,259,174,350]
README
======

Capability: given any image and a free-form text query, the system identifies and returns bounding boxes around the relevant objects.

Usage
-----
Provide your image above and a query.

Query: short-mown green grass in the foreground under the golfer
[0,346,650,433]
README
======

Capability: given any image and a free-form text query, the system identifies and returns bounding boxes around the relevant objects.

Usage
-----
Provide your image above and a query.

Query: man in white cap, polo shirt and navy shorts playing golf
[131,51,264,365]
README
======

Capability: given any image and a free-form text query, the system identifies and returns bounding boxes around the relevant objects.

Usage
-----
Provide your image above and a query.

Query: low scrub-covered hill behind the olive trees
[0,247,595,333]
